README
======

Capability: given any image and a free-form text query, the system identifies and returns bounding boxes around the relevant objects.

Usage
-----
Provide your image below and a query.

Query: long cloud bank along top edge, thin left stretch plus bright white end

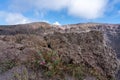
[11,0,108,19]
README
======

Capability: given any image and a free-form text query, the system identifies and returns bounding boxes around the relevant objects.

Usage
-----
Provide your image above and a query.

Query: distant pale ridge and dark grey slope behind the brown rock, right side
[65,23,120,58]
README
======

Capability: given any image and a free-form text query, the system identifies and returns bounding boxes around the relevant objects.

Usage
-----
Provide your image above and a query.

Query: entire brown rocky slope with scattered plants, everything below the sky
[0,23,120,80]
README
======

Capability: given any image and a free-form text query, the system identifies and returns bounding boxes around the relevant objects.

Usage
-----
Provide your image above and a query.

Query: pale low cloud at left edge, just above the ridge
[0,11,31,24]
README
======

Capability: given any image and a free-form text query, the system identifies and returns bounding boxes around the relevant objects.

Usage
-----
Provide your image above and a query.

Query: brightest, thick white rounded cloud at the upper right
[68,0,107,19]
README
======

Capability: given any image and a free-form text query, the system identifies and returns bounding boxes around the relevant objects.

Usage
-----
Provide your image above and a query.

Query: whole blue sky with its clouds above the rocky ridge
[0,0,120,25]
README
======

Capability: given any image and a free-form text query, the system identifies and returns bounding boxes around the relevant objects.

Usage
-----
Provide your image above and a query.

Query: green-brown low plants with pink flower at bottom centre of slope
[24,51,103,80]
